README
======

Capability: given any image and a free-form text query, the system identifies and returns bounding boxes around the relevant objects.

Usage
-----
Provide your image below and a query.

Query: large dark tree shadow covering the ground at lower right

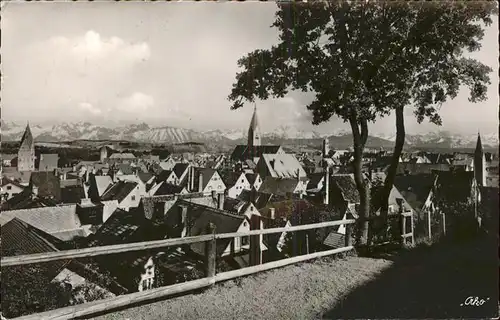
[321,232,499,319]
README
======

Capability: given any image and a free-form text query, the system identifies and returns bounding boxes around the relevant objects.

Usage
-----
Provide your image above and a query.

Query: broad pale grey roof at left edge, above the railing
[0,205,90,241]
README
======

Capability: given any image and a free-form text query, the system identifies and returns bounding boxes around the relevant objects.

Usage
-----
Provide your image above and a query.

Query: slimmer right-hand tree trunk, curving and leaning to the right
[378,107,406,229]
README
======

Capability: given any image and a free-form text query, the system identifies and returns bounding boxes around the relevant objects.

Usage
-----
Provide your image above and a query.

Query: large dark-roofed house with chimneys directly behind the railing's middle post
[166,200,267,262]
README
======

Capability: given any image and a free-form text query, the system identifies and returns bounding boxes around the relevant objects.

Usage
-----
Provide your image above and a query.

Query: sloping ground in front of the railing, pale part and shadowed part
[93,235,498,320]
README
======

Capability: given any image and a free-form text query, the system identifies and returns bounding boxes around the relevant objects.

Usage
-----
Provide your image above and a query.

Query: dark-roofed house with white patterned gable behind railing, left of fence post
[84,208,165,292]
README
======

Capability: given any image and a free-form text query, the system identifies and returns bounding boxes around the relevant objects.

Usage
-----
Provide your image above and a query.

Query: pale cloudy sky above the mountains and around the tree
[1,1,499,134]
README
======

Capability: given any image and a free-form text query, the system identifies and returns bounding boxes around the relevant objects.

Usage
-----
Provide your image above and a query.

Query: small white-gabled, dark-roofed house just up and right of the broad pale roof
[101,181,146,211]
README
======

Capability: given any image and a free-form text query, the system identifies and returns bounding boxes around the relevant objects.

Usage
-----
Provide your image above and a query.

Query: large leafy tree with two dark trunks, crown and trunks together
[229,1,496,239]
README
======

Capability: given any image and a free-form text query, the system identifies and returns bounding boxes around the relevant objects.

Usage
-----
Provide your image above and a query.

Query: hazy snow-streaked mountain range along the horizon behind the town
[1,120,498,148]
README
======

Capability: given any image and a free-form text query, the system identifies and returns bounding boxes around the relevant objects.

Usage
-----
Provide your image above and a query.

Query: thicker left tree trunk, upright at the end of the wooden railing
[349,116,370,244]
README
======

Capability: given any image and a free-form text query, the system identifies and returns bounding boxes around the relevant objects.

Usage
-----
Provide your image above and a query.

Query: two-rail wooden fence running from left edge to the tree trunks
[0,219,355,320]
